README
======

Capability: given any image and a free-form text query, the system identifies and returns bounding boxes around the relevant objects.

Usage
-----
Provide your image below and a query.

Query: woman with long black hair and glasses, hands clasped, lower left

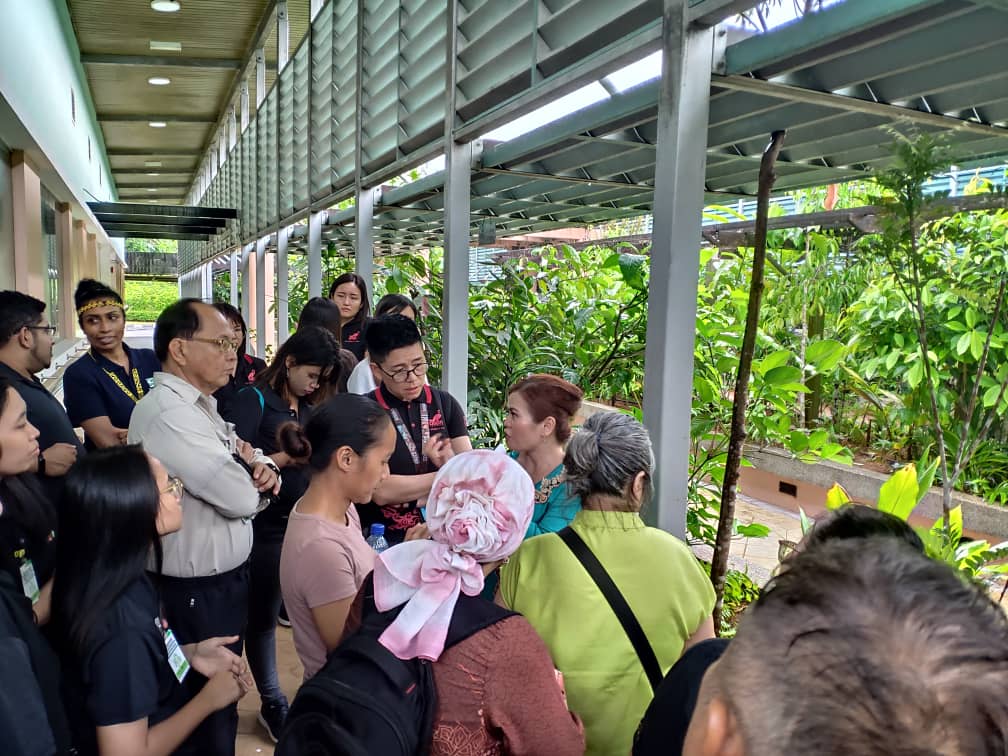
[52,446,251,756]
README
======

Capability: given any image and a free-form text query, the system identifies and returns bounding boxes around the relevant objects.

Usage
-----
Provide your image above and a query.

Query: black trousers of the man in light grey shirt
[156,562,249,756]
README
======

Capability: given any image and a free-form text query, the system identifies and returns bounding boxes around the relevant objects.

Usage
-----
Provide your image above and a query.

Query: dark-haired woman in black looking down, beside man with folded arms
[234,326,339,738]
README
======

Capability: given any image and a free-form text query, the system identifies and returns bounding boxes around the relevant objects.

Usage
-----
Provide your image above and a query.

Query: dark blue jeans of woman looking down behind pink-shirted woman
[245,531,287,706]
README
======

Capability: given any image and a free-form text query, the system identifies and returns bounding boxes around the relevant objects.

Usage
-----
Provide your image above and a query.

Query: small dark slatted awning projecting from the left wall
[88,203,238,242]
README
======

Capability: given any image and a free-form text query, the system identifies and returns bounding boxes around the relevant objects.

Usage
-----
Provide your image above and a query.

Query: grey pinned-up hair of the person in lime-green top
[563,412,654,500]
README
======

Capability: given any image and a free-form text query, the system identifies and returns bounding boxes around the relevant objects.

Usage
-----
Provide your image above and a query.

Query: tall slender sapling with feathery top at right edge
[866,134,1008,530]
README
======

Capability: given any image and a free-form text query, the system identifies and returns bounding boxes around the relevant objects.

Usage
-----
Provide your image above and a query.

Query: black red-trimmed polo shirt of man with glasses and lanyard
[361,386,469,542]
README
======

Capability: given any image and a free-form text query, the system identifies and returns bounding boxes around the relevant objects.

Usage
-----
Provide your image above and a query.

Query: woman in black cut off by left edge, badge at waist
[0,377,56,624]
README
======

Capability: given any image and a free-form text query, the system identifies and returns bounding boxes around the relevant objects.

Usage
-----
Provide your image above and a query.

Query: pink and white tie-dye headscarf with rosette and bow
[374,451,535,661]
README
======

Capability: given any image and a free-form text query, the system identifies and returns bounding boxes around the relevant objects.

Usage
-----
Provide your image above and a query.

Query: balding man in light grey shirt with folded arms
[129,299,280,754]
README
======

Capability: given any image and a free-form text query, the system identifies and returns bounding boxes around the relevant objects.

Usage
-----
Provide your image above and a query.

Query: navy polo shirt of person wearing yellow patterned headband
[64,344,161,449]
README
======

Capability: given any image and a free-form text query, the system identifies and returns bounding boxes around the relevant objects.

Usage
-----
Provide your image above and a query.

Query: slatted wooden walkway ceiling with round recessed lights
[67,0,310,205]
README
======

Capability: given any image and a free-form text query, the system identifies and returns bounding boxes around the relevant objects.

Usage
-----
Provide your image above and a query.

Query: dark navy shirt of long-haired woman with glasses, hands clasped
[61,576,194,754]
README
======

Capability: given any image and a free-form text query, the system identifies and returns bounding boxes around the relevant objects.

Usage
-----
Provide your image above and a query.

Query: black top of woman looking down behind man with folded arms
[232,386,311,541]
